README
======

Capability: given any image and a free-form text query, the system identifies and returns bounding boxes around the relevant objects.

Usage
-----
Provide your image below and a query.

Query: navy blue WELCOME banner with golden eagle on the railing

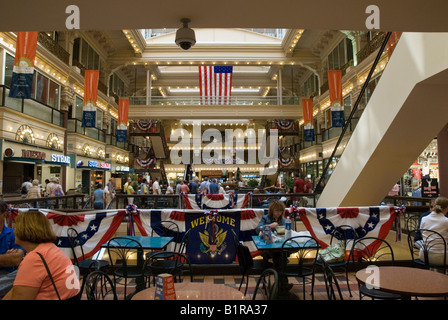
[185,210,241,264]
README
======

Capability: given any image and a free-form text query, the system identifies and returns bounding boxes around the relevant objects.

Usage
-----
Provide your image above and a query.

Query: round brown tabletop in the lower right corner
[356,266,448,299]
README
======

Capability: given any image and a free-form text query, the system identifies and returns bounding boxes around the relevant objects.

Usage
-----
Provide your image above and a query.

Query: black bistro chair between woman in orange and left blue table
[67,228,109,292]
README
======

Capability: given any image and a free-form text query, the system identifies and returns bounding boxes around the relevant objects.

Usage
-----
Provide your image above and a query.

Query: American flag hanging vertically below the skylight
[199,66,233,105]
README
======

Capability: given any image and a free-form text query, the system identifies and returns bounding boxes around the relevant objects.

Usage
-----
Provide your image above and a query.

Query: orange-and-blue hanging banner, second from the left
[82,70,100,128]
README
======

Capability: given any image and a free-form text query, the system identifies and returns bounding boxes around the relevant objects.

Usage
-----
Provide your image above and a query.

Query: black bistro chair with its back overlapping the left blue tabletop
[107,237,151,299]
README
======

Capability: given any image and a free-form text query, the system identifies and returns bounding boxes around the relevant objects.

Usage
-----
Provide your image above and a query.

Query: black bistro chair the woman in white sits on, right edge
[408,229,447,274]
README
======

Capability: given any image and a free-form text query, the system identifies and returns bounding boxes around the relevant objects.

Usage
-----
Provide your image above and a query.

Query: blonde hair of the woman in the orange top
[14,210,56,243]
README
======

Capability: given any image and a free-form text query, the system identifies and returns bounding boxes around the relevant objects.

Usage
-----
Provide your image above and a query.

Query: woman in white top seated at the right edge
[420,197,448,265]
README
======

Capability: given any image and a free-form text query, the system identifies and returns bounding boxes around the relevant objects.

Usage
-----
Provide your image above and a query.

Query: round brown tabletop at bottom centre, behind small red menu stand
[132,282,245,300]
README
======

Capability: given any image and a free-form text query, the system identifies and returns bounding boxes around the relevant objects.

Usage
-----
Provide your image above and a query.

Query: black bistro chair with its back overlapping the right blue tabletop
[281,236,319,299]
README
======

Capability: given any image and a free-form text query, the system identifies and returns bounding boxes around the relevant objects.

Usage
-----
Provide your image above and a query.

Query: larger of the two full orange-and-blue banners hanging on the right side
[328,70,345,127]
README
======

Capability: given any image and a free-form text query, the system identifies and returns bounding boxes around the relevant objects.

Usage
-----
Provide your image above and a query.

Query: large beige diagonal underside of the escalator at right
[317,33,448,207]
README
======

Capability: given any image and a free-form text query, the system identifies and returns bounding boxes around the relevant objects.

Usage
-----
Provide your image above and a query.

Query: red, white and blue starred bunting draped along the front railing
[9,206,403,258]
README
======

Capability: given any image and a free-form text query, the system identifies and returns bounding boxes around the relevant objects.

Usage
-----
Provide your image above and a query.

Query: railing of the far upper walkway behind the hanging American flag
[129,96,300,106]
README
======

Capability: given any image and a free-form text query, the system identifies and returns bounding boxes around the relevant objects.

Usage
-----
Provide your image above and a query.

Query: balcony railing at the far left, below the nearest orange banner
[0,85,64,127]
